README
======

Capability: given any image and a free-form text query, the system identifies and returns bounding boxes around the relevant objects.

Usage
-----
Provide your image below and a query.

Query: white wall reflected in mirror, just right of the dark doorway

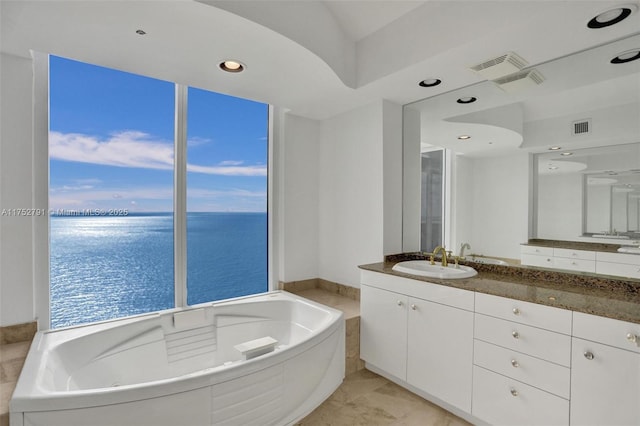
[454,154,530,259]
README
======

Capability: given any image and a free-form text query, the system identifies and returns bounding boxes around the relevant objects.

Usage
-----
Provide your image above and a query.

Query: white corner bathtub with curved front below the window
[10,291,345,426]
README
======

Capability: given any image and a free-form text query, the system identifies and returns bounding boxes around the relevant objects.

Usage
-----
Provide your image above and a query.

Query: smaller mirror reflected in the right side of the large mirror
[535,143,640,244]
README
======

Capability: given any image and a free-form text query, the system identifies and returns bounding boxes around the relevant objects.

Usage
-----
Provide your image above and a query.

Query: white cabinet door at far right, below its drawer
[571,337,640,426]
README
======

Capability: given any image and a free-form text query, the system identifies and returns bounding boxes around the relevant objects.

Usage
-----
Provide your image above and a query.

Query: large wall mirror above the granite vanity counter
[403,34,640,263]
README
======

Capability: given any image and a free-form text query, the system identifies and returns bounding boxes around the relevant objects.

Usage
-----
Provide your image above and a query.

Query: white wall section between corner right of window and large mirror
[318,101,402,287]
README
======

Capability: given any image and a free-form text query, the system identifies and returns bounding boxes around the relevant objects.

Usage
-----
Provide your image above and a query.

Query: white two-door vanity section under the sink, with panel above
[360,271,474,412]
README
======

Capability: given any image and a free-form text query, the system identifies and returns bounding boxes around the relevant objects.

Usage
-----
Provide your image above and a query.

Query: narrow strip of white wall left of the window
[0,54,36,326]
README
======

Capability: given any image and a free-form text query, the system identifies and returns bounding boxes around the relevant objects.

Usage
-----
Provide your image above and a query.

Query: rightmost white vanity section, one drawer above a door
[571,312,640,426]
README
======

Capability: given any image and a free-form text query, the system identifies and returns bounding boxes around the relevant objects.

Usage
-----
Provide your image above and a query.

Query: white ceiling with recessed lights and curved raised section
[0,0,640,119]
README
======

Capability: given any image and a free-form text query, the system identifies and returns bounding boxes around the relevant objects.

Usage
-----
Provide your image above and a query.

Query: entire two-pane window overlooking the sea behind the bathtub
[49,56,268,328]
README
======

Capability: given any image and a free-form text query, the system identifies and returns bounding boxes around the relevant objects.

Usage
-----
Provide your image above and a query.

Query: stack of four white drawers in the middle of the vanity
[472,293,571,425]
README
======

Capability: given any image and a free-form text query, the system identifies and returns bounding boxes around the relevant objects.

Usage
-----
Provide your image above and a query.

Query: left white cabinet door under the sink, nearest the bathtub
[360,285,408,380]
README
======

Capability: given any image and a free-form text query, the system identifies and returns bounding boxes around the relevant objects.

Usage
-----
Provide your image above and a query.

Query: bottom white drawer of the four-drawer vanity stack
[472,366,569,425]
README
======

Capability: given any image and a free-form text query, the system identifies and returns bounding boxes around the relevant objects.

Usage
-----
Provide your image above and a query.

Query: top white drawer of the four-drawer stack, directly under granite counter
[476,293,571,334]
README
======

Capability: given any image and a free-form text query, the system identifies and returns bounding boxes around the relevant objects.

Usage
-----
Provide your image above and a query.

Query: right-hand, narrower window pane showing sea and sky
[187,88,268,305]
